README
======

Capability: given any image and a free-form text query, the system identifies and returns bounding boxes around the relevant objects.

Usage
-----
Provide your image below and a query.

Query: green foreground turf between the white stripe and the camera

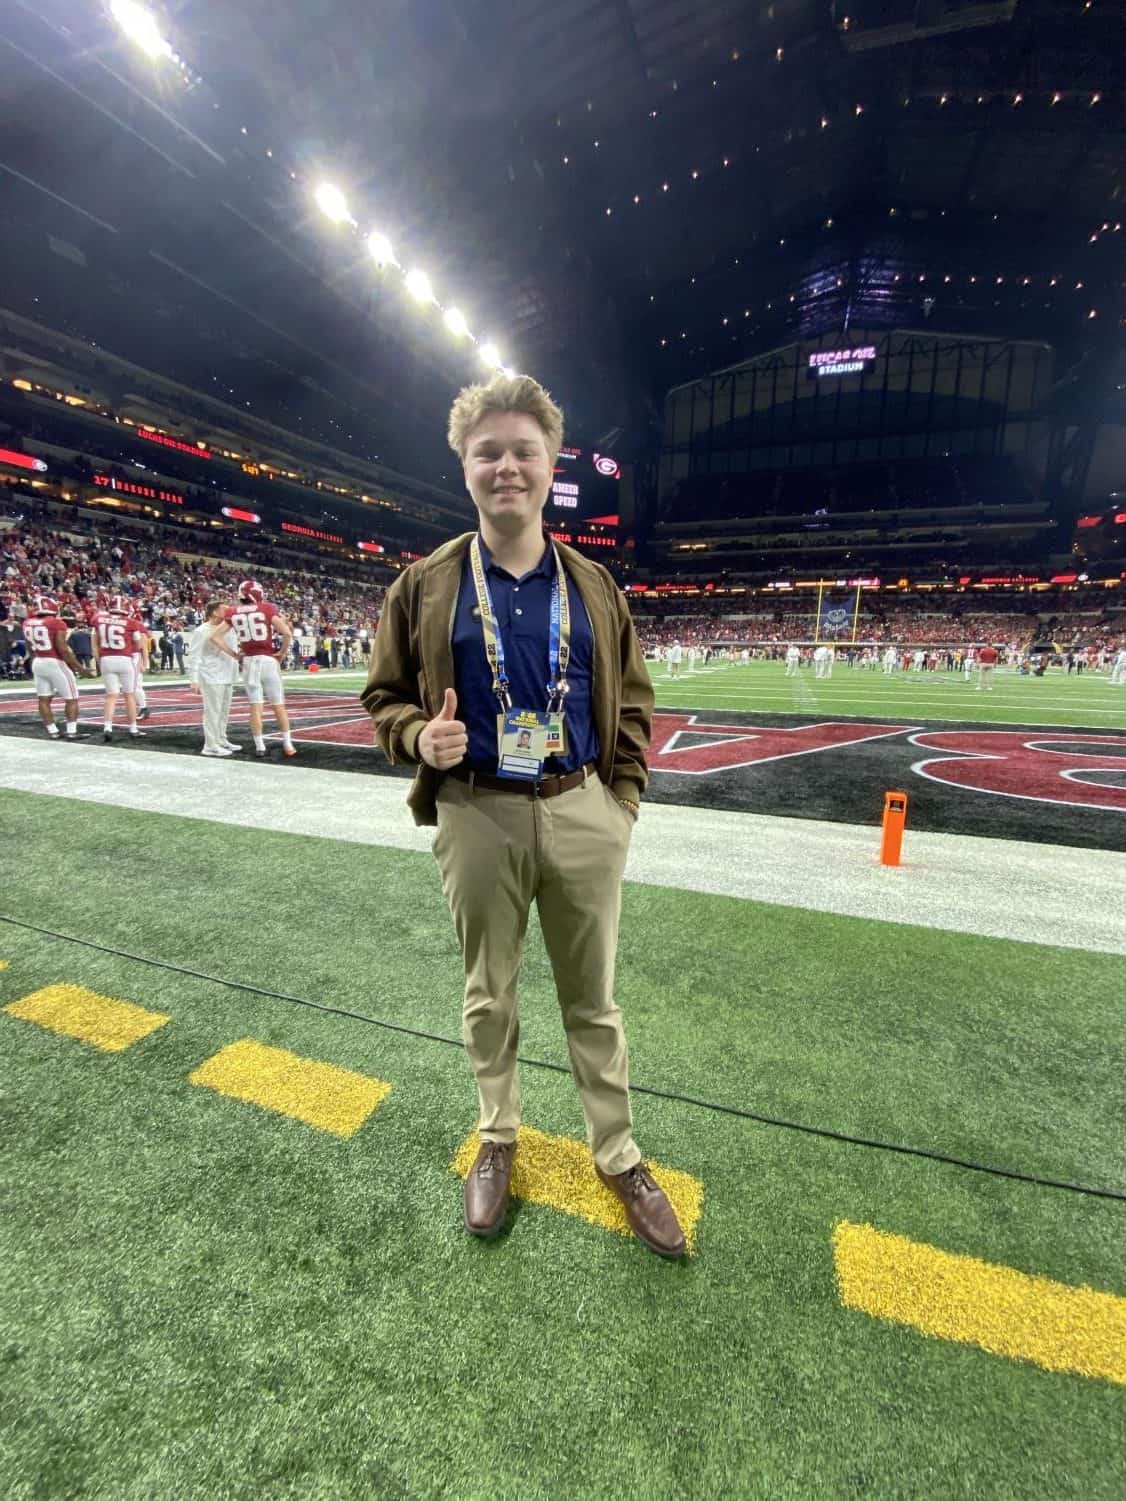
[0,793,1126,1501]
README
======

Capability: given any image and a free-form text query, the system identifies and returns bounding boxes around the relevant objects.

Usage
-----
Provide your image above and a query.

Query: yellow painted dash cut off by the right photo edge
[833,1220,1126,1385]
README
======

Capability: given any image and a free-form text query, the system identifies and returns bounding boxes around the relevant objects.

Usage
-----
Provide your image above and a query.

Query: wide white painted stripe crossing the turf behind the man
[0,737,1126,967]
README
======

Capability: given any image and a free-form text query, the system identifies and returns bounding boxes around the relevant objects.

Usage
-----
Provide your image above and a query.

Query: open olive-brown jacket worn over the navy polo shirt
[360,531,653,826]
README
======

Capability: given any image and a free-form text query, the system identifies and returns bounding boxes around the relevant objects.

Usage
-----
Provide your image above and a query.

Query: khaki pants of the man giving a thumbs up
[434,773,641,1172]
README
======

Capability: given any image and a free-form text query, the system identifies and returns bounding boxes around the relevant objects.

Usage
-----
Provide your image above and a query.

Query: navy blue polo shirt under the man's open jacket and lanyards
[452,539,599,776]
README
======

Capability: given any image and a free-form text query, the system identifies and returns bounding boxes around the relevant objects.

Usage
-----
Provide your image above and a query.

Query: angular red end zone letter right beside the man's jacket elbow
[649,714,914,776]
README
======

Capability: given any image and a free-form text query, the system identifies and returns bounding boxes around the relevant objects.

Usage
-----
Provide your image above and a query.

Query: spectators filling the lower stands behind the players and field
[0,503,1126,677]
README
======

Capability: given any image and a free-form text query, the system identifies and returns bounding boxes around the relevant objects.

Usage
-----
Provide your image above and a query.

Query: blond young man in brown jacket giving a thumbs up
[363,375,685,1256]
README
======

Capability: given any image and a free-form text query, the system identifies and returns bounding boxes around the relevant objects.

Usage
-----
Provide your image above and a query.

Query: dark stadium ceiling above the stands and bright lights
[0,0,1126,479]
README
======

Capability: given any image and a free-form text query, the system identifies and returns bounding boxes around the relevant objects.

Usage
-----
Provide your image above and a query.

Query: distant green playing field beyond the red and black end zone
[287,662,1126,731]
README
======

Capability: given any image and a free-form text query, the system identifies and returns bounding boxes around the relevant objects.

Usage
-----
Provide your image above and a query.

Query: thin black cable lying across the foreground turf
[0,913,1126,1202]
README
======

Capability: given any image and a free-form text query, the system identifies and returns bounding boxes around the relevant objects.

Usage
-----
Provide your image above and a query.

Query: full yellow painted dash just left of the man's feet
[188,1037,390,1138]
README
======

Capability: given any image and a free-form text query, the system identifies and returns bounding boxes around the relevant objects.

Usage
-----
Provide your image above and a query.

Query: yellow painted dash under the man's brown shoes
[450,1126,704,1253]
